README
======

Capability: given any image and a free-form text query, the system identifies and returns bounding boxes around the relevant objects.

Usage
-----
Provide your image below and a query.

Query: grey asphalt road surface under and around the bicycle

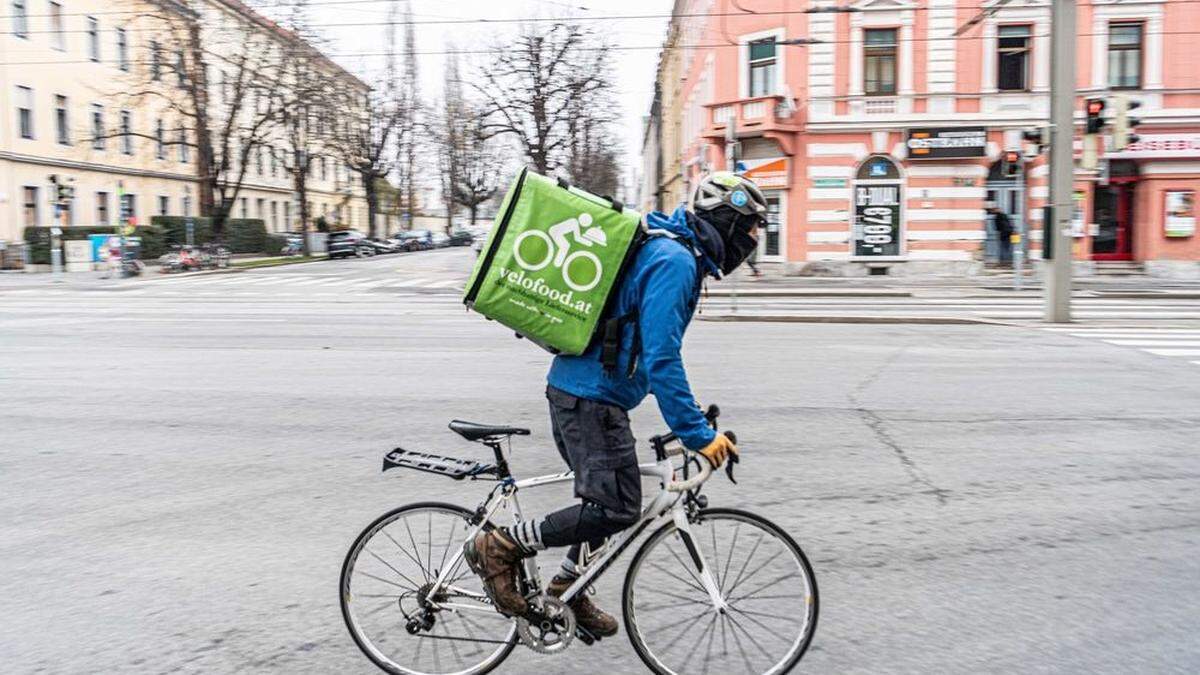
[0,252,1200,674]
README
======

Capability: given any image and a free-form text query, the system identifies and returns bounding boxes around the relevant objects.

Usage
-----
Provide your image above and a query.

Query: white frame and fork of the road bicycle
[427,448,726,613]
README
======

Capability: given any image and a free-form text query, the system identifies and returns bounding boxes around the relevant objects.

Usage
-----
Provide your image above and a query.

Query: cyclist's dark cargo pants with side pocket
[541,387,642,562]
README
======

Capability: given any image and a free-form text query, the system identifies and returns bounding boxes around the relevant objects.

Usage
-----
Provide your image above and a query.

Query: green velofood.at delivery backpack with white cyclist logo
[463,168,642,357]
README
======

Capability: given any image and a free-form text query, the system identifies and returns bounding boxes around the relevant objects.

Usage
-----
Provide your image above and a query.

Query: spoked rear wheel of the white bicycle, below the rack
[341,502,516,675]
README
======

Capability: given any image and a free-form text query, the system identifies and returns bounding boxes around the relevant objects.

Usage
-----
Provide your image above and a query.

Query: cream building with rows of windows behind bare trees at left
[0,0,367,247]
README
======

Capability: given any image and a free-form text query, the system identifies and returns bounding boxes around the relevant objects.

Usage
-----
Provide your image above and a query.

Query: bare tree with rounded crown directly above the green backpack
[474,22,611,173]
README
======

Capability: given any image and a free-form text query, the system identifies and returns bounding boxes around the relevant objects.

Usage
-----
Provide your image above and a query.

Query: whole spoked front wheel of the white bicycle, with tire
[622,508,817,675]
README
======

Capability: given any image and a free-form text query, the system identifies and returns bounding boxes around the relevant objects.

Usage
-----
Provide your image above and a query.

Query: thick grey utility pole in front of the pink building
[1044,0,1075,323]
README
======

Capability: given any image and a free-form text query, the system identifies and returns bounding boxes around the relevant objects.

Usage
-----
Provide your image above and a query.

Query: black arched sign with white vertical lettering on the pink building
[850,155,902,258]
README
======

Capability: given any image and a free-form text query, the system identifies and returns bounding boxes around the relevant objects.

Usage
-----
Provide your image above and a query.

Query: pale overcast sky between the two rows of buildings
[251,0,673,181]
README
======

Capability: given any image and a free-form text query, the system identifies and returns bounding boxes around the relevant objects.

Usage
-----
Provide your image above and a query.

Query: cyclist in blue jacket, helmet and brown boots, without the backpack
[464,172,767,637]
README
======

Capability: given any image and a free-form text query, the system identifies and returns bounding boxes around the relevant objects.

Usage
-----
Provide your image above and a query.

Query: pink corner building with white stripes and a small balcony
[655,0,1200,275]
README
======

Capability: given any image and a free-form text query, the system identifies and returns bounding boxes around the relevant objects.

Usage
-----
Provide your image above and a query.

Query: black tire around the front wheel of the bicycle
[622,508,820,675]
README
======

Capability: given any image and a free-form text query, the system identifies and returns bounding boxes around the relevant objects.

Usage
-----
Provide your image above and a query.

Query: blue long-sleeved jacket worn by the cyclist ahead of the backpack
[546,207,715,449]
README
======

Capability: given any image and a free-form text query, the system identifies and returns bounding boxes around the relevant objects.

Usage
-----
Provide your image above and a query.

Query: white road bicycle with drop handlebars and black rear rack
[340,406,817,675]
